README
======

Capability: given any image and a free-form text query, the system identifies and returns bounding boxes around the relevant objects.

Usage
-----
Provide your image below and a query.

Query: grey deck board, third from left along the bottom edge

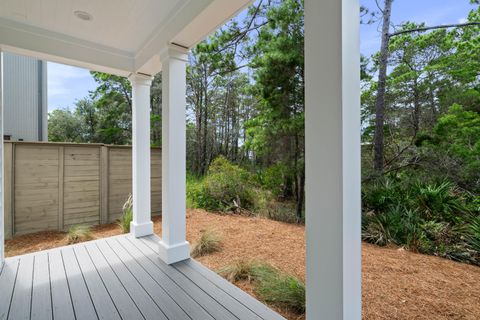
[31,252,53,319]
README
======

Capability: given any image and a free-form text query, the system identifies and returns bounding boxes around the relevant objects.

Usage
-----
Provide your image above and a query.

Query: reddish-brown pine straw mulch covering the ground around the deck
[6,210,480,320]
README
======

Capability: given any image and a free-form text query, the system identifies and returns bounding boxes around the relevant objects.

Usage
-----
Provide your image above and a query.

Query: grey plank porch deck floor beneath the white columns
[0,235,283,320]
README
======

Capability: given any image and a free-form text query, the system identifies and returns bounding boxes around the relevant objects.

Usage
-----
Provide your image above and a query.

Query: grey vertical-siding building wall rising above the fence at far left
[3,53,48,141]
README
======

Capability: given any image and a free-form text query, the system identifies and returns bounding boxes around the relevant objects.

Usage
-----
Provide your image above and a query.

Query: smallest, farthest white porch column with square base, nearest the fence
[128,74,153,238]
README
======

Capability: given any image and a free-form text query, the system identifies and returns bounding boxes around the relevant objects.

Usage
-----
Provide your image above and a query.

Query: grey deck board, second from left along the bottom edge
[8,256,35,320]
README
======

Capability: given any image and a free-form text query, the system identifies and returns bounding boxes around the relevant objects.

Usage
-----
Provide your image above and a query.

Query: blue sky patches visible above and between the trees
[48,0,473,111]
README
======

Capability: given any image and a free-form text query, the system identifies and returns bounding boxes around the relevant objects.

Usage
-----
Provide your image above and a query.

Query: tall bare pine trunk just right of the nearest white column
[373,0,393,173]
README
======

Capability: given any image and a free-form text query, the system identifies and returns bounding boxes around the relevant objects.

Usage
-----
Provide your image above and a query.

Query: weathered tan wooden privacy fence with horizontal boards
[4,141,162,239]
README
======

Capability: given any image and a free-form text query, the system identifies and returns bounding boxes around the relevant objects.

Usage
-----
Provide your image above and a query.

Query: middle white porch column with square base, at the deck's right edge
[159,46,190,264]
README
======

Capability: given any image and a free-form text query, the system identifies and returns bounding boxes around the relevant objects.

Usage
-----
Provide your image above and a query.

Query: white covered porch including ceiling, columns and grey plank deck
[0,0,361,319]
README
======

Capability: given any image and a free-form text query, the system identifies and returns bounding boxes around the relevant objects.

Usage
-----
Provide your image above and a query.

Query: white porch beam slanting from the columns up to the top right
[135,0,253,75]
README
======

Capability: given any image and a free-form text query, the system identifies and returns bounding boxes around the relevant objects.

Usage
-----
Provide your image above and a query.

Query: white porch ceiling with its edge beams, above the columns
[0,0,251,75]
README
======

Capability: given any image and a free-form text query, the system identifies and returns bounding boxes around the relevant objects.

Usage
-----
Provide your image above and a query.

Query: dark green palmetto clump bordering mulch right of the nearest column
[362,172,480,264]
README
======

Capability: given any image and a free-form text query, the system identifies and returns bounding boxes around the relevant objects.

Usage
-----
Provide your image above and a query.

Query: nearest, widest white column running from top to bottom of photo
[305,0,362,320]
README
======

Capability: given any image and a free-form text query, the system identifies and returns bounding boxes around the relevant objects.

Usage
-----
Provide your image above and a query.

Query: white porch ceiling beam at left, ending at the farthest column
[0,18,134,76]
